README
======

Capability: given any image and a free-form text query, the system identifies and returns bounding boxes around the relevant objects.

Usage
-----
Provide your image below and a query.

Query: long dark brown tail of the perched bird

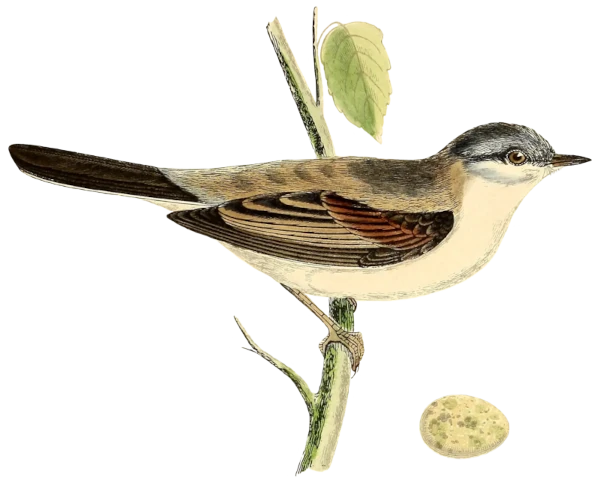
[8,144,198,203]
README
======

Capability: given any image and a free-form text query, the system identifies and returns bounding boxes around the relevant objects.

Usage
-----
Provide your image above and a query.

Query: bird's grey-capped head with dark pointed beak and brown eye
[443,121,591,185]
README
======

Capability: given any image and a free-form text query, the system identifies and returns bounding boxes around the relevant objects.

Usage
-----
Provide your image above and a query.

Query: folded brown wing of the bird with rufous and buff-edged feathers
[167,192,454,267]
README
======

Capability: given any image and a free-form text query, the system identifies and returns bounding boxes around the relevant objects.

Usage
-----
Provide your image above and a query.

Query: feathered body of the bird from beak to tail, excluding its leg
[9,121,590,302]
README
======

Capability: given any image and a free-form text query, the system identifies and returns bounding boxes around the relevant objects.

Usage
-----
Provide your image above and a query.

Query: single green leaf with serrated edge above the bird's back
[320,20,393,144]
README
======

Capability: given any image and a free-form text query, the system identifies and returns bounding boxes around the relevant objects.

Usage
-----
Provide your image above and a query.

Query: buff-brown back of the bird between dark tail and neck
[162,156,464,211]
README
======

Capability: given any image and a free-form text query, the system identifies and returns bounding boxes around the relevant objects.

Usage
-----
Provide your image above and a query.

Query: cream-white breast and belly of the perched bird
[220,174,536,303]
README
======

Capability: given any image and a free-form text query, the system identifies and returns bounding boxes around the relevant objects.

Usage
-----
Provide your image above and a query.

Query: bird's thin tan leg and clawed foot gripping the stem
[281,285,366,374]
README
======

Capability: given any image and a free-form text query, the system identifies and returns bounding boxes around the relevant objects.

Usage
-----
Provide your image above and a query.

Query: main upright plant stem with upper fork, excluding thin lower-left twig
[267,6,356,476]
